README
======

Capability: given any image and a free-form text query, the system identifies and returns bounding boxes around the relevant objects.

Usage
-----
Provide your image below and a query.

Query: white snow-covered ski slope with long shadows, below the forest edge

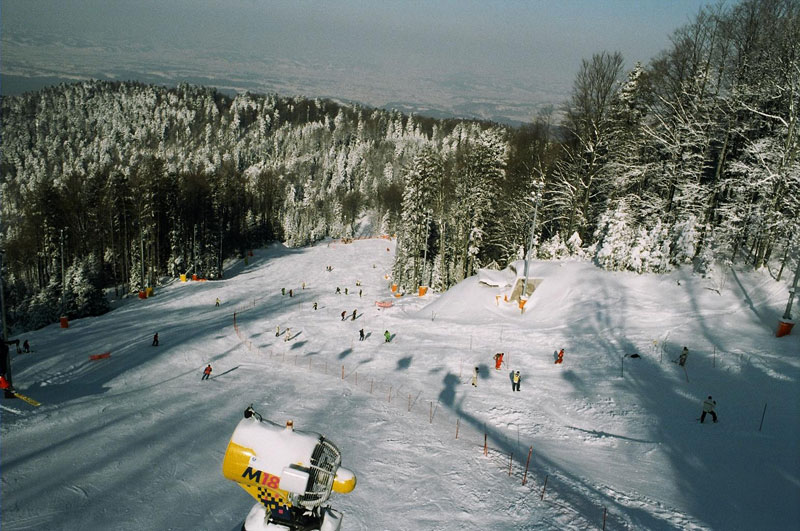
[0,239,800,531]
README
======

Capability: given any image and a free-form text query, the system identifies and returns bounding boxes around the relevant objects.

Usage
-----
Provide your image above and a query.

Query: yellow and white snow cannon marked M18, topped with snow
[222,406,356,531]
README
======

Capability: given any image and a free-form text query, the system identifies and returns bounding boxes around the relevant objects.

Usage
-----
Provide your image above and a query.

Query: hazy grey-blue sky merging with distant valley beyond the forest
[0,0,709,122]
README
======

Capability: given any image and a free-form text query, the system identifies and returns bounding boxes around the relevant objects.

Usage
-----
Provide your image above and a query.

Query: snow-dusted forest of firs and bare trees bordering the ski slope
[0,0,800,328]
